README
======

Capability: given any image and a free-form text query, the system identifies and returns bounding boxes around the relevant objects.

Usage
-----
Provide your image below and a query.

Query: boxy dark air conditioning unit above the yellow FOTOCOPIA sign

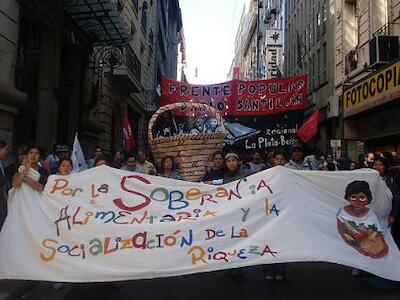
[369,35,399,69]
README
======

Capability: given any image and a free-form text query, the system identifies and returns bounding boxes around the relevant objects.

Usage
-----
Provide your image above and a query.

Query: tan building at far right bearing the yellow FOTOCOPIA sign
[335,0,400,159]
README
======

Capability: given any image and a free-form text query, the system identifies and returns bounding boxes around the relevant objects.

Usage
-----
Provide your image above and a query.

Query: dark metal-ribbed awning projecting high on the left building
[63,0,128,45]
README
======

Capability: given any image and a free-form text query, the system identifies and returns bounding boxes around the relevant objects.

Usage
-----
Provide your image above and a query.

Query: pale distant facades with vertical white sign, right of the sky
[228,0,284,80]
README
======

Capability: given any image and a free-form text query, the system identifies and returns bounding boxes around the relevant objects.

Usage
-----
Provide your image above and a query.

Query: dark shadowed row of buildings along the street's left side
[0,0,182,156]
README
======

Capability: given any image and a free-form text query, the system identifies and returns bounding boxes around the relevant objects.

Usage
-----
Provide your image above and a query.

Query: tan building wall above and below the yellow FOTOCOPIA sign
[335,0,400,158]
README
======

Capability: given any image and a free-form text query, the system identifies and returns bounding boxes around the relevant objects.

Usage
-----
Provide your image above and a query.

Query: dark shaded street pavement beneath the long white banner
[9,263,400,300]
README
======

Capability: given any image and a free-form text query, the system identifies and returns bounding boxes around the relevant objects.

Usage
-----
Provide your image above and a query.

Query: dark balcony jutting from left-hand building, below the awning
[112,45,143,93]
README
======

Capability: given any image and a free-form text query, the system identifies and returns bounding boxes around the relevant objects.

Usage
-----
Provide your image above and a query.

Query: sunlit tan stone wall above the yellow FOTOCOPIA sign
[335,0,400,95]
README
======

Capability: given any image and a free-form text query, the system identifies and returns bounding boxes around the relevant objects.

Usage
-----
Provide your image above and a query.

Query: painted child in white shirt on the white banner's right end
[337,180,388,258]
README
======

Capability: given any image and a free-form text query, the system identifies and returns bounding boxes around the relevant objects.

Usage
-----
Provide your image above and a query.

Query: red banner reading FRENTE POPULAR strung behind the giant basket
[160,75,307,116]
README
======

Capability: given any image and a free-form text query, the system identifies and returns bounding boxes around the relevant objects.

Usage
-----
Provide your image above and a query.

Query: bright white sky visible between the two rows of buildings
[179,0,248,84]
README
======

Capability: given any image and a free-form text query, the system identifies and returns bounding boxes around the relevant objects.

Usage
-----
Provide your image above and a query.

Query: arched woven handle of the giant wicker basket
[148,102,226,143]
